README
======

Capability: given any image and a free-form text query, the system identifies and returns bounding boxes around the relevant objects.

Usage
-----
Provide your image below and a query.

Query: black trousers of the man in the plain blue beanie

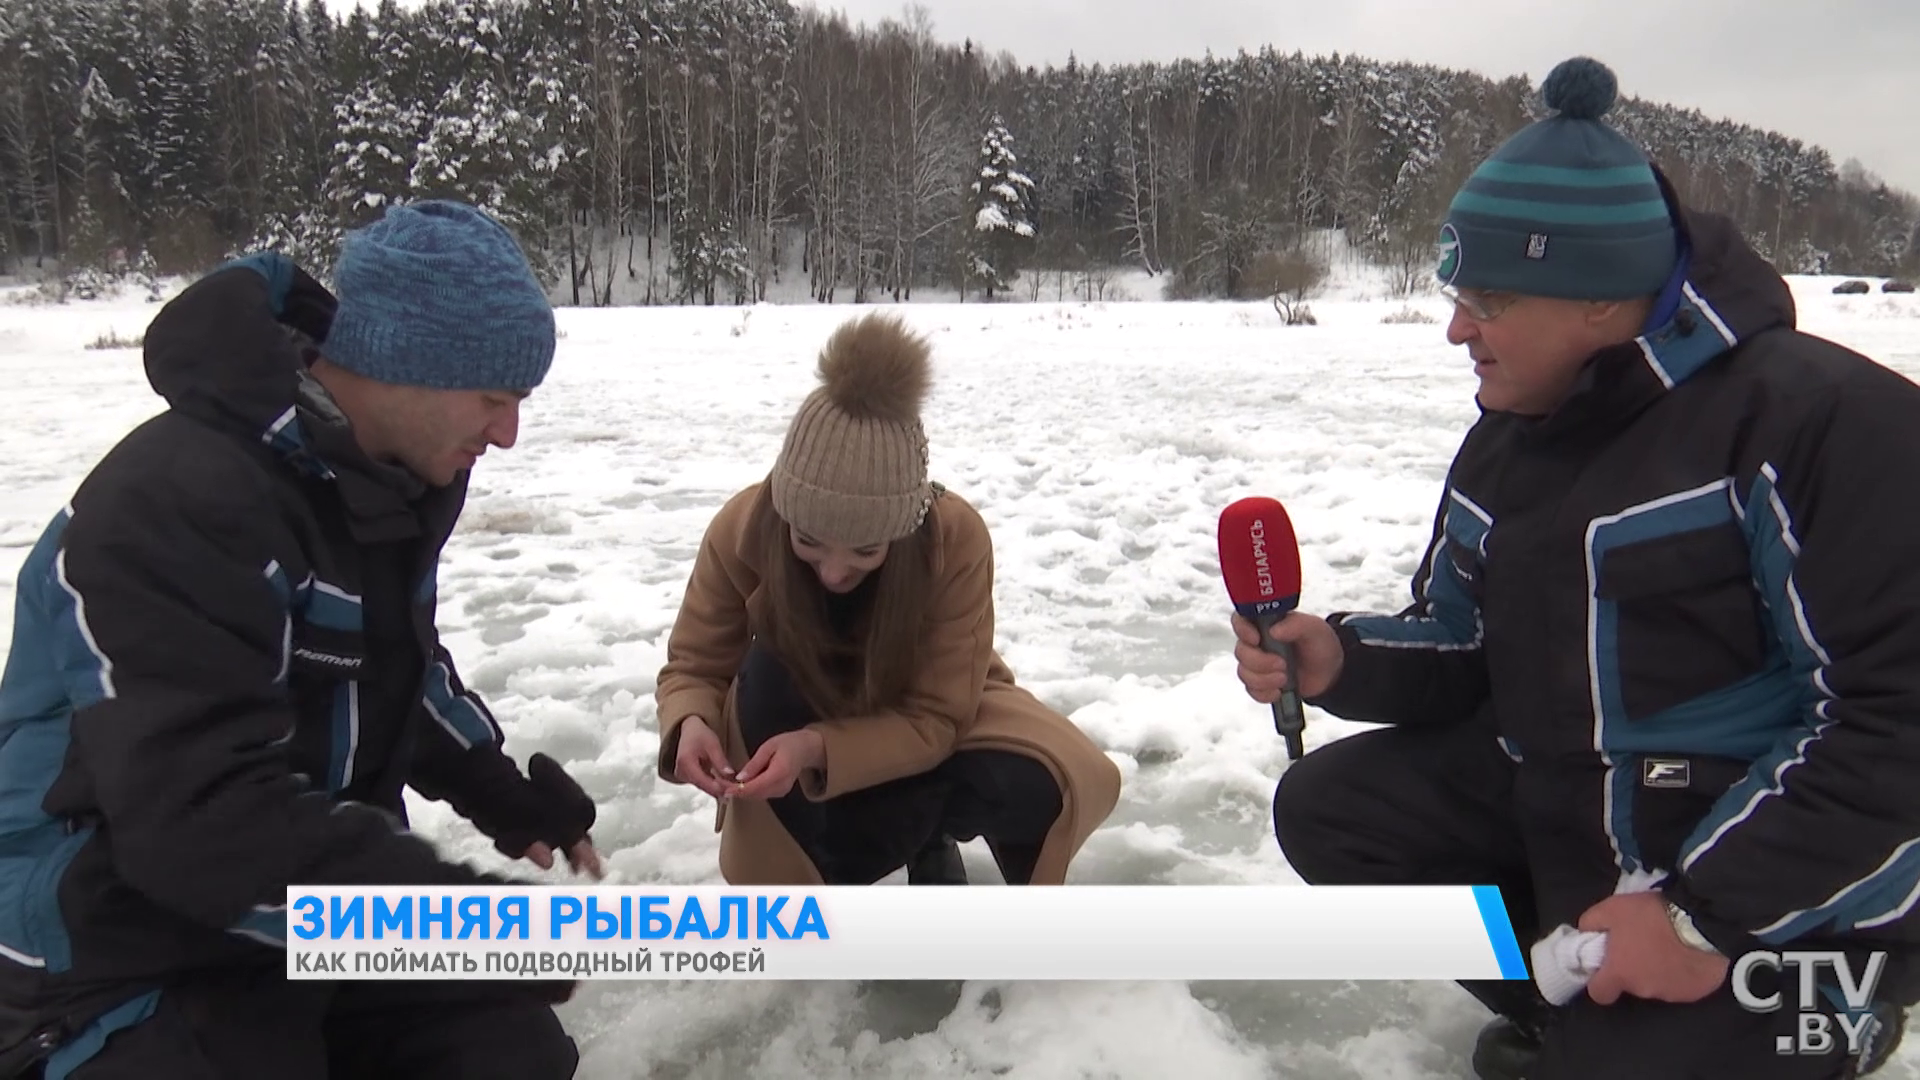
[52,969,580,1080]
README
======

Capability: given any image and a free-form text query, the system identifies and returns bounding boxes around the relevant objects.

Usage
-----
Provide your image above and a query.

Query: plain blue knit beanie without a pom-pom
[321,200,555,390]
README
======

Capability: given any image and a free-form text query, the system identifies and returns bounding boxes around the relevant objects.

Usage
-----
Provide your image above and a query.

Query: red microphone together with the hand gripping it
[1219,498,1344,761]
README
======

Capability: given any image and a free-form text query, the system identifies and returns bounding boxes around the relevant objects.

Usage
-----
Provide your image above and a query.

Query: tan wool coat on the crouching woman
[655,484,1119,886]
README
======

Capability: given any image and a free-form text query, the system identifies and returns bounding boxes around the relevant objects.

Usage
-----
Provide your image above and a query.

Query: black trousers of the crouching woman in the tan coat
[735,644,1062,884]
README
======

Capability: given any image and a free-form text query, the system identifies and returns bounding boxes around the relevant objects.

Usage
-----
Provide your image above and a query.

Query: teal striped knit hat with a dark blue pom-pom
[1436,56,1678,300]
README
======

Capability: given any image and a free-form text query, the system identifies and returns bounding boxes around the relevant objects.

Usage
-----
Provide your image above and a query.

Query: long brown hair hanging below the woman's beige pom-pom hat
[749,484,933,719]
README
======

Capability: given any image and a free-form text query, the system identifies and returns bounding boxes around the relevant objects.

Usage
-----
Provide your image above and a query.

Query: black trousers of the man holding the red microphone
[1273,721,1845,1080]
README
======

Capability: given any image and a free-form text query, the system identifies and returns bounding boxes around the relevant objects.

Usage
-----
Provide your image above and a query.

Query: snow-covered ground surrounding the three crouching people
[11,281,1920,1080]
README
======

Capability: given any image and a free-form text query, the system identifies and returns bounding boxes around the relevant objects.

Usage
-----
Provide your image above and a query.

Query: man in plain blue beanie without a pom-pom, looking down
[0,202,599,1080]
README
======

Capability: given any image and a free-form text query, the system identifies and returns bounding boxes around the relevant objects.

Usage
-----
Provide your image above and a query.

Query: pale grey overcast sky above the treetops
[330,0,1920,194]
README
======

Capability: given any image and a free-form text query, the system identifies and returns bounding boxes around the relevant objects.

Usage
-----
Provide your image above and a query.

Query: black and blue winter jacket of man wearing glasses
[1317,171,1920,980]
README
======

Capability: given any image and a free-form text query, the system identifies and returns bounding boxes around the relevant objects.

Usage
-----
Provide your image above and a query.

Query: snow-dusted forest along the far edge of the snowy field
[0,0,1920,306]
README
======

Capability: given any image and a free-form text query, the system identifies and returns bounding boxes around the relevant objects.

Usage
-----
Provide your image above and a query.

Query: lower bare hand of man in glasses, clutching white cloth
[1580,892,1728,1005]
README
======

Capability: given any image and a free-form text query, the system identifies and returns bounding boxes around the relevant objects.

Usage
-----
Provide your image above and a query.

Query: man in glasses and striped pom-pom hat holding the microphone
[1235,60,1920,1080]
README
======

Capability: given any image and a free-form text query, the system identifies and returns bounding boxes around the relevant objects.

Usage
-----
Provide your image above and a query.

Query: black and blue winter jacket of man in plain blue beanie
[0,256,586,1049]
